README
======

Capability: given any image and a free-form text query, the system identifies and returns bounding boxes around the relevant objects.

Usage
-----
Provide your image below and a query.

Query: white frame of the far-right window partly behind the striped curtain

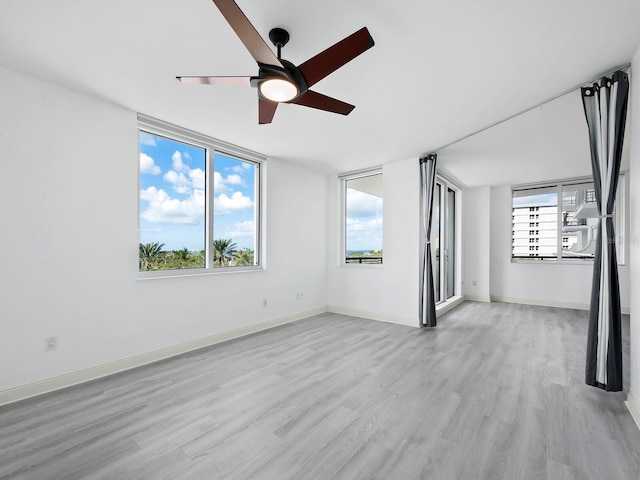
[509,172,628,266]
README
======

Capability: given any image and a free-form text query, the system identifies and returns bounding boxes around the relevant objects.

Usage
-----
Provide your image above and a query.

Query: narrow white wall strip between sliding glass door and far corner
[462,187,491,302]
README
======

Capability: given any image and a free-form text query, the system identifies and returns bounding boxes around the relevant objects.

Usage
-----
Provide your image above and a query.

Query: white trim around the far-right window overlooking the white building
[509,172,628,267]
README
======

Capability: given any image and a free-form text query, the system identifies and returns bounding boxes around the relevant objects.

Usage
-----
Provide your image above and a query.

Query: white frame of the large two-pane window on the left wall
[136,114,267,279]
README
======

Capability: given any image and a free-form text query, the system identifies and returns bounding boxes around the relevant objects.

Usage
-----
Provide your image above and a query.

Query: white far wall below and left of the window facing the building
[491,187,630,311]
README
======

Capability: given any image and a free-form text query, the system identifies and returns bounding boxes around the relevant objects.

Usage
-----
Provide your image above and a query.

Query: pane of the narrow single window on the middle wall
[345,173,382,263]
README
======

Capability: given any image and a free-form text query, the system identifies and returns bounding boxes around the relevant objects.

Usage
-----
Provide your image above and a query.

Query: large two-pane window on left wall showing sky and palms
[138,119,261,273]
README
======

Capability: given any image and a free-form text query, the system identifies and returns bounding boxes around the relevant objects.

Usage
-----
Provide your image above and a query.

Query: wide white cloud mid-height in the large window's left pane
[140,187,204,225]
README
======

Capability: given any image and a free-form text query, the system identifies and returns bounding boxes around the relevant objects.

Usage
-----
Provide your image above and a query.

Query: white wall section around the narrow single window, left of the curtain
[328,158,420,326]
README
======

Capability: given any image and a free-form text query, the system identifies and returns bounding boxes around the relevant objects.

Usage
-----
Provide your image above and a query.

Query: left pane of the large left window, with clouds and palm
[139,131,206,271]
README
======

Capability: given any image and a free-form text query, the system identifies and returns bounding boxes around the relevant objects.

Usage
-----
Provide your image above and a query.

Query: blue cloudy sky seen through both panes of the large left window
[139,132,256,251]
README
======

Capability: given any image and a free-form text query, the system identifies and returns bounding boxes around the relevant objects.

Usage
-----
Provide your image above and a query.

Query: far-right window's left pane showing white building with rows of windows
[511,187,558,260]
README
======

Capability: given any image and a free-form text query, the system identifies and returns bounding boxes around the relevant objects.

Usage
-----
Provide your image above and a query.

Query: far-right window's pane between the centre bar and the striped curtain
[562,182,598,260]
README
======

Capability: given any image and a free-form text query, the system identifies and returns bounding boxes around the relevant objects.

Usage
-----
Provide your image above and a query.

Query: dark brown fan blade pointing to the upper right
[298,27,374,87]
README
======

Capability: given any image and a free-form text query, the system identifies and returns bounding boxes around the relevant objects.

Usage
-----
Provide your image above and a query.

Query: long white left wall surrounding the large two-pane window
[0,69,328,403]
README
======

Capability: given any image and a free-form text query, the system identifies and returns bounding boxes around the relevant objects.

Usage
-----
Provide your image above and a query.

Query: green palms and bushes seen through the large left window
[138,239,254,272]
